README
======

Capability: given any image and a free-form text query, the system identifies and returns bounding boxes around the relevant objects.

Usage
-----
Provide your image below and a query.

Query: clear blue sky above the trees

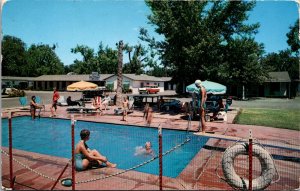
[2,0,299,65]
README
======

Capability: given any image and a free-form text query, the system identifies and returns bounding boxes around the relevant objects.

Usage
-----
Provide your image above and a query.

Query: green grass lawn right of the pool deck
[235,108,300,131]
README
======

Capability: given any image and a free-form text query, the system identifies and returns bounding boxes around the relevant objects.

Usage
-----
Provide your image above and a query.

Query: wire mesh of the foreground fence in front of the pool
[1,116,300,190]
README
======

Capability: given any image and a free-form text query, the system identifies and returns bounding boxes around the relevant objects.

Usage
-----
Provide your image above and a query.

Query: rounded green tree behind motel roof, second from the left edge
[26,44,64,76]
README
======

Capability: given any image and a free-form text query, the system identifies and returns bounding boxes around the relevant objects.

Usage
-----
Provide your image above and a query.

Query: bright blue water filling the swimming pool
[2,116,208,178]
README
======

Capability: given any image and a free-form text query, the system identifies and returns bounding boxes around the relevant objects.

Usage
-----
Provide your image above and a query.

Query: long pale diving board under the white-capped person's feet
[194,132,300,152]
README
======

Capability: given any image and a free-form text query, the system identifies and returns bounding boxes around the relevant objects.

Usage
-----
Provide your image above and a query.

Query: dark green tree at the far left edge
[2,35,28,76]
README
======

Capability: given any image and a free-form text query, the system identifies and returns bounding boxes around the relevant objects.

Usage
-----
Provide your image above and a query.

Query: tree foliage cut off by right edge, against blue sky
[286,19,300,54]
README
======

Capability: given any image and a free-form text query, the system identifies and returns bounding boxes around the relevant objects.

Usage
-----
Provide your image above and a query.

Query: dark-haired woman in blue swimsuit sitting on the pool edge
[75,129,117,171]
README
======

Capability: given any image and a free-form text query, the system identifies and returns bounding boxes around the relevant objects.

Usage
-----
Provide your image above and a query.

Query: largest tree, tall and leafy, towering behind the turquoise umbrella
[140,1,260,92]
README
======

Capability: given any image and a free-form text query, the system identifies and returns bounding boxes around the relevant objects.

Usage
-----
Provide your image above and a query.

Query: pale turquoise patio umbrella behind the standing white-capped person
[186,80,227,95]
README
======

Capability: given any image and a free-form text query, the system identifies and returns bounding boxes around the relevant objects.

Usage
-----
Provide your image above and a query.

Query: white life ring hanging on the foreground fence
[222,143,276,190]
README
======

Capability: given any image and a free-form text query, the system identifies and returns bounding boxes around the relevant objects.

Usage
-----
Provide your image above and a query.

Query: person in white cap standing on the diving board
[195,80,207,133]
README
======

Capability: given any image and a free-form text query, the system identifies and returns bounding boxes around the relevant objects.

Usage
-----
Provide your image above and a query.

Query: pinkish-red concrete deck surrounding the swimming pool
[2,105,300,190]
